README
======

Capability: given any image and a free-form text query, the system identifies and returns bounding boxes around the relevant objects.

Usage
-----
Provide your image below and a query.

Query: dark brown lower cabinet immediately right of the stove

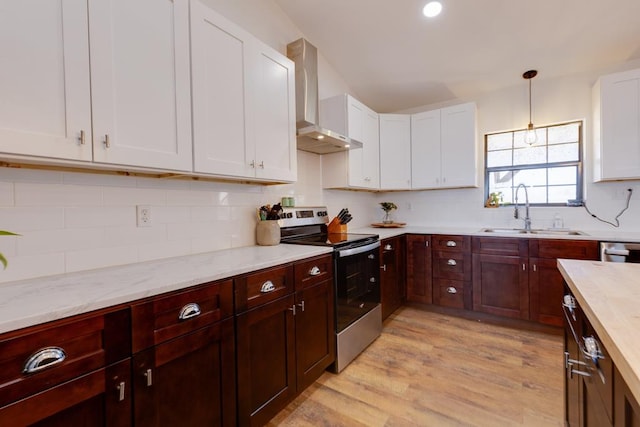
[380,236,405,320]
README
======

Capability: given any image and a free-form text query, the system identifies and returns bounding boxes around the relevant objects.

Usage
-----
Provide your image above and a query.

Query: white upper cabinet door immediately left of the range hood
[251,41,297,181]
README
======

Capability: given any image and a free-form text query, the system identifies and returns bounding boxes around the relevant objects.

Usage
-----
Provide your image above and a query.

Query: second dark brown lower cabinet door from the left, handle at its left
[133,318,236,426]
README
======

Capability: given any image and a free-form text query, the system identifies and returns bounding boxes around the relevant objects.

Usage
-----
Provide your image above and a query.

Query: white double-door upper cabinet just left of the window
[411,103,478,189]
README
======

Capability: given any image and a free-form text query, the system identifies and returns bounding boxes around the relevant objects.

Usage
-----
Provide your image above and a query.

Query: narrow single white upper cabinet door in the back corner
[379,114,411,190]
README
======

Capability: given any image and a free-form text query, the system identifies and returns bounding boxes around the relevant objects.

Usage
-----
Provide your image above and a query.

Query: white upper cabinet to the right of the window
[593,69,640,181]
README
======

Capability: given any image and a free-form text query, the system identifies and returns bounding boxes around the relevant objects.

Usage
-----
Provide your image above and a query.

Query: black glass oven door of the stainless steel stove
[335,241,380,332]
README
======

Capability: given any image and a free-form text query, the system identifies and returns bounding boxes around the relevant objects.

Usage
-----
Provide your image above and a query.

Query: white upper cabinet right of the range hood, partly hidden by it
[320,94,380,190]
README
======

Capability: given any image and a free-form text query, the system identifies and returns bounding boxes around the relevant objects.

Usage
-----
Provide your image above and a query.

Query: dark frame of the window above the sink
[484,120,584,207]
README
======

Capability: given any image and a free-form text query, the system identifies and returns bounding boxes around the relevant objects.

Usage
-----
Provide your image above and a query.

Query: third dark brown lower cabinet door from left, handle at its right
[236,294,296,426]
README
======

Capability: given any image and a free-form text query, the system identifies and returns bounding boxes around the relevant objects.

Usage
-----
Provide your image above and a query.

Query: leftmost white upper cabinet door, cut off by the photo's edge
[0,0,92,161]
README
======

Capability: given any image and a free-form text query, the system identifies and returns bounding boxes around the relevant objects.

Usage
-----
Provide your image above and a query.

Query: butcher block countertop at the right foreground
[558,259,640,401]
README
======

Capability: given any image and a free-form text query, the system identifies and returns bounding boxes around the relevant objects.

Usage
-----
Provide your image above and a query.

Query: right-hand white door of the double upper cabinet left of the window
[440,103,478,188]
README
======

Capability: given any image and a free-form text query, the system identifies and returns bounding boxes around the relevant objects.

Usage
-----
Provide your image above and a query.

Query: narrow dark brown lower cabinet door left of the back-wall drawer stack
[406,234,433,304]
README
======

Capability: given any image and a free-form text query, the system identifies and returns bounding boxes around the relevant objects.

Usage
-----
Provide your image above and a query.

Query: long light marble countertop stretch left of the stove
[0,244,332,333]
